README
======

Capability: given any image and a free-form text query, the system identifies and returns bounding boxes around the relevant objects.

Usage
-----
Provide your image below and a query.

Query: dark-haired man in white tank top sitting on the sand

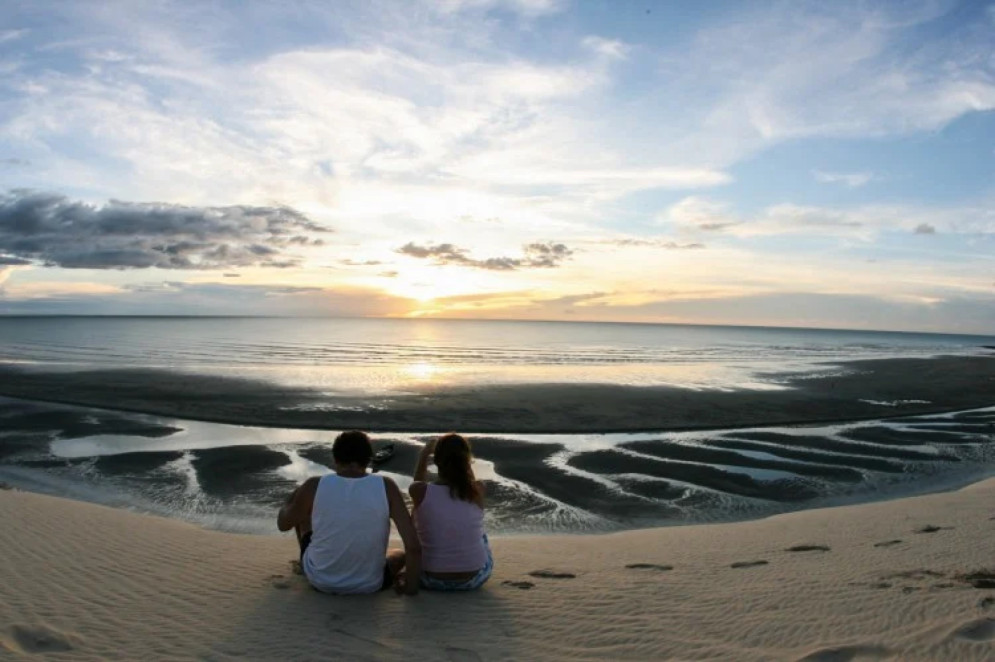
[276,430,421,595]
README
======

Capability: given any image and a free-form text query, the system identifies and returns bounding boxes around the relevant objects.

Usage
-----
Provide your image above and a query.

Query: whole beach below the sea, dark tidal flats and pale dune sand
[0,322,995,662]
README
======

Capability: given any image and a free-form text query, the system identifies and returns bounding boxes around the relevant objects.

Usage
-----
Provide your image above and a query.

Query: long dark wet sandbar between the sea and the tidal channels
[0,356,995,434]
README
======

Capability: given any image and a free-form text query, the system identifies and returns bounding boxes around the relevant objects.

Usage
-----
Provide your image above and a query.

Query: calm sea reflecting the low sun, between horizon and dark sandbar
[0,317,995,394]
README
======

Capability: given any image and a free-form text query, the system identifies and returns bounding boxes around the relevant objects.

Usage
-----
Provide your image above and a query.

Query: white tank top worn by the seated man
[301,474,390,593]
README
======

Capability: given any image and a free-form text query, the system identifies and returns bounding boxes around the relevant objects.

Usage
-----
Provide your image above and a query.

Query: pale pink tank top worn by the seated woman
[414,483,487,572]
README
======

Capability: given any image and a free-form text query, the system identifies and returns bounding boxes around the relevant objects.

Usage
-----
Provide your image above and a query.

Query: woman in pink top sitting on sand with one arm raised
[408,434,494,591]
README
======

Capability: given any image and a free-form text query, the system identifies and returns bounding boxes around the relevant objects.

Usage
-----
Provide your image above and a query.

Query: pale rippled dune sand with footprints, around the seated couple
[0,480,995,660]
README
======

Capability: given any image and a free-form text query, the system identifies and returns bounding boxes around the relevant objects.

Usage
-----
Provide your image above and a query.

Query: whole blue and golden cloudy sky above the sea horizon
[0,0,995,334]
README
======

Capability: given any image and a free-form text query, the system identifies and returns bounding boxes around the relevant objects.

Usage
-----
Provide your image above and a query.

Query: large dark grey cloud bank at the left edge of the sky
[0,190,328,269]
